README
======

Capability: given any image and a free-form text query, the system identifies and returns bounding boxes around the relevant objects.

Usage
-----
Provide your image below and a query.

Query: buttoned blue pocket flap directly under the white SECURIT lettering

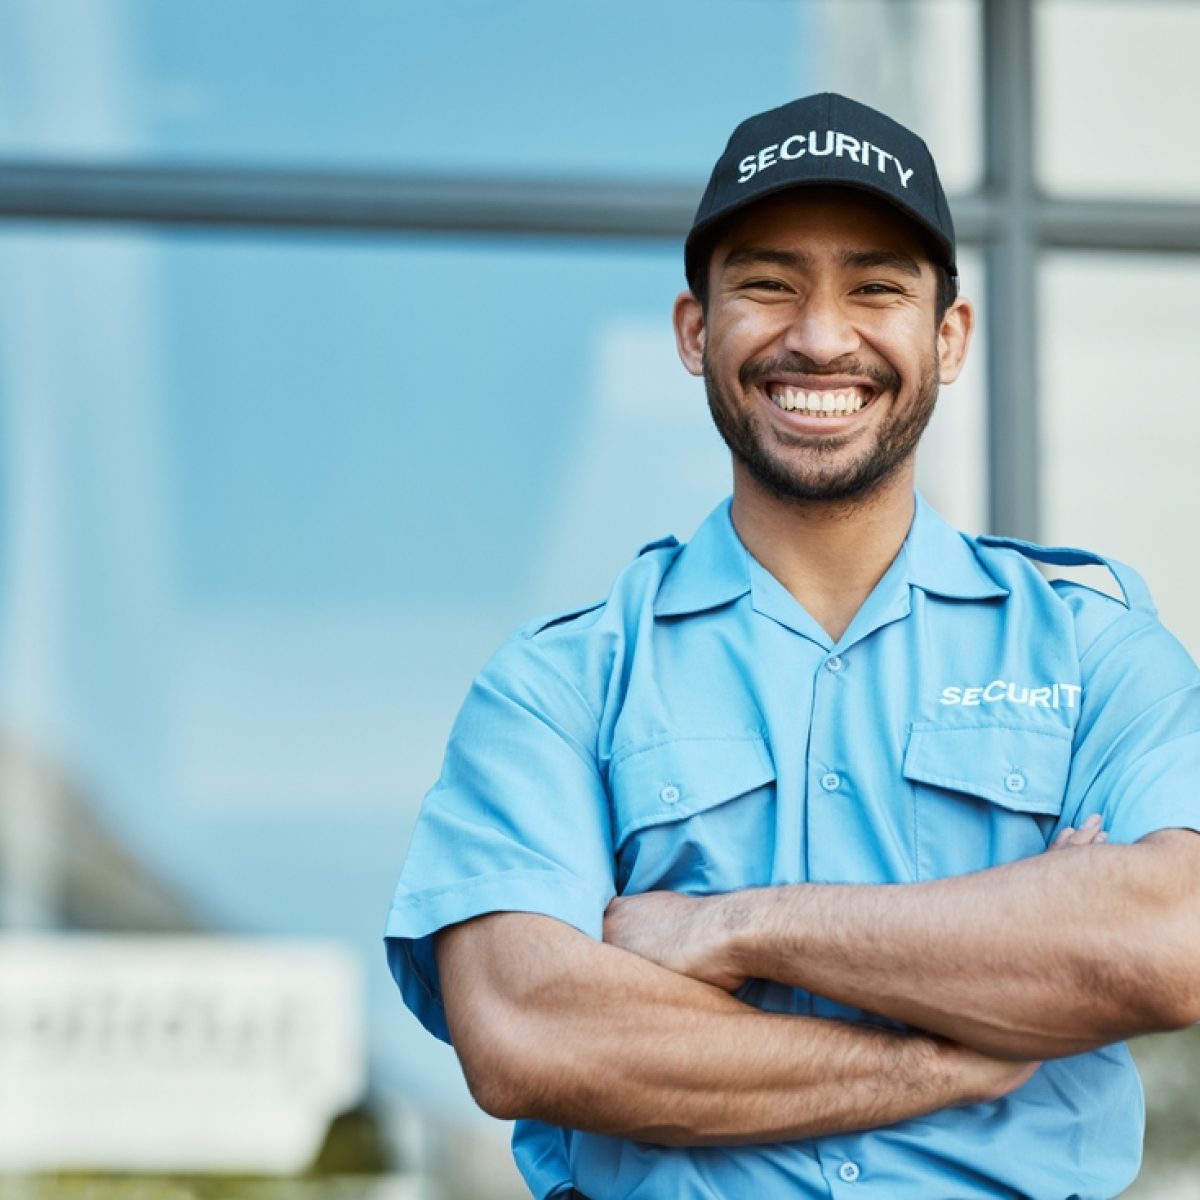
[904,722,1072,814]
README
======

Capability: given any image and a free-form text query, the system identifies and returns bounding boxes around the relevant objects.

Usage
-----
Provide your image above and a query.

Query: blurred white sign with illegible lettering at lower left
[0,935,365,1174]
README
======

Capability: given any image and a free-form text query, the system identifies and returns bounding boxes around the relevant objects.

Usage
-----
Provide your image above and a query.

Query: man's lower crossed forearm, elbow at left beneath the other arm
[438,913,1028,1145]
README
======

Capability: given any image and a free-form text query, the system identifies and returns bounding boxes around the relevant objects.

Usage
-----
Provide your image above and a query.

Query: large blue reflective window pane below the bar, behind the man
[0,218,983,1104]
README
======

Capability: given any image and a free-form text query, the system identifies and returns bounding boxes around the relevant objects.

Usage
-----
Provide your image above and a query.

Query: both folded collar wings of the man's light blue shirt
[654,493,1008,617]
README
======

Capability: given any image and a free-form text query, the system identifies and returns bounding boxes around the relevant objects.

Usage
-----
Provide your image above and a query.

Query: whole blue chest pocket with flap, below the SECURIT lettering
[904,722,1072,880]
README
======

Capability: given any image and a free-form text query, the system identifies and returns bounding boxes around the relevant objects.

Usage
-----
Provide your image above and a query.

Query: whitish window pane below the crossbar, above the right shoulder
[1040,253,1200,655]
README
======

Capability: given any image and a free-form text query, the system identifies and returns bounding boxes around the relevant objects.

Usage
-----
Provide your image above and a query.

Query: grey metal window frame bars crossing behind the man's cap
[0,0,1200,539]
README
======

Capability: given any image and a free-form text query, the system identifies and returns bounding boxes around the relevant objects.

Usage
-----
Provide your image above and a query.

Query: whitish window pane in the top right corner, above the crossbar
[1034,0,1200,200]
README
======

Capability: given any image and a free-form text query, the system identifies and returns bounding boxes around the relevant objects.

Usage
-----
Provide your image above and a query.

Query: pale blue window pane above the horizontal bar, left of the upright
[0,0,978,187]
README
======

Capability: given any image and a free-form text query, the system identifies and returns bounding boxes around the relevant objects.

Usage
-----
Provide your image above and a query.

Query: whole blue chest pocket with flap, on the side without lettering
[610,733,775,894]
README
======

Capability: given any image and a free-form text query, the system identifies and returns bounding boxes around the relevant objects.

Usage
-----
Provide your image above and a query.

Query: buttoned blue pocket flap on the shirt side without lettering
[610,733,775,850]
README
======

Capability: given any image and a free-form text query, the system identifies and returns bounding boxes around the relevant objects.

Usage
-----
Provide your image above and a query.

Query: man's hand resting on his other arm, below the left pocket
[604,892,746,991]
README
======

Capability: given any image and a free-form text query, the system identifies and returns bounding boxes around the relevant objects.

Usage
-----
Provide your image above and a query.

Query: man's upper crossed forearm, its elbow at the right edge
[714,833,1200,1058]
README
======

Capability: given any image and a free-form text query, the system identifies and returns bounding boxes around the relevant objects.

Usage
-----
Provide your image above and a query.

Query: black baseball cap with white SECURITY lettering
[684,91,958,290]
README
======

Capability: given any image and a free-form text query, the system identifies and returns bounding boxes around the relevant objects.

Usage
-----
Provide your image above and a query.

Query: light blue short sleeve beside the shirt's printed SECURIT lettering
[1063,598,1200,842]
